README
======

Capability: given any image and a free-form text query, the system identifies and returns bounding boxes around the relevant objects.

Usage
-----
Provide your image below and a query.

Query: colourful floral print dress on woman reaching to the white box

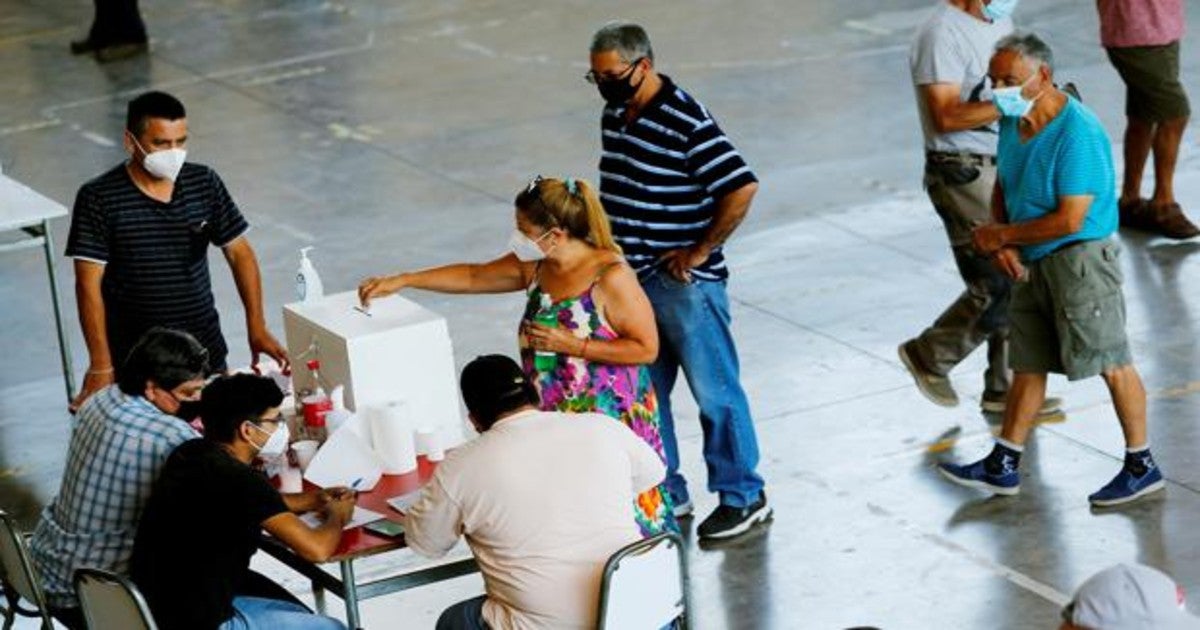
[521,265,679,536]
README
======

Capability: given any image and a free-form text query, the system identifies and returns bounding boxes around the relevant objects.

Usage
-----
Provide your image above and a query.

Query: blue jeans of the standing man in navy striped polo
[642,270,763,508]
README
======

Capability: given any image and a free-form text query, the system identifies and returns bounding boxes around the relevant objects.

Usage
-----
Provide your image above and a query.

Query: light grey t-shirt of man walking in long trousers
[908,1,1013,155]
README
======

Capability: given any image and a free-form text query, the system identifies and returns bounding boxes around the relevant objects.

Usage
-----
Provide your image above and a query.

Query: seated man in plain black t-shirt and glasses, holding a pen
[131,374,354,630]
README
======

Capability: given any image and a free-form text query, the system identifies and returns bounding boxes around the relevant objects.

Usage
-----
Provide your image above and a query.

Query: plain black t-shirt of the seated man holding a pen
[131,439,288,630]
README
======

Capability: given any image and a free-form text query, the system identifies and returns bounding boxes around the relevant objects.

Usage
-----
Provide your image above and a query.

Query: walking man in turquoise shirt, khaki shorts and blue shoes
[938,35,1163,506]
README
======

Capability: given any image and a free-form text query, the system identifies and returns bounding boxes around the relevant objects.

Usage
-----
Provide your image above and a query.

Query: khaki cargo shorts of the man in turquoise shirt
[1008,239,1133,380]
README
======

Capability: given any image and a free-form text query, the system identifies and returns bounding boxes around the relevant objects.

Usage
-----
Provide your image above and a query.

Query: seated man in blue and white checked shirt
[30,329,208,629]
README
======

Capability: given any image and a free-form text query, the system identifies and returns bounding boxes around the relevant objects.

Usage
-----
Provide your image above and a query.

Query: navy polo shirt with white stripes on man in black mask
[600,76,757,280]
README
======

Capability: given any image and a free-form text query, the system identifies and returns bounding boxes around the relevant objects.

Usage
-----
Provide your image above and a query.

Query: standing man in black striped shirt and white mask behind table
[66,92,287,410]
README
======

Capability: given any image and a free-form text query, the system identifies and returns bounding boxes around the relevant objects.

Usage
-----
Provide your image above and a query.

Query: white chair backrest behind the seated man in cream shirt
[598,533,690,630]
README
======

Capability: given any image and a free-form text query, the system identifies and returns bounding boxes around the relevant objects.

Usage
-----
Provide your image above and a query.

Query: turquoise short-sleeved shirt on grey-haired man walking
[996,96,1117,263]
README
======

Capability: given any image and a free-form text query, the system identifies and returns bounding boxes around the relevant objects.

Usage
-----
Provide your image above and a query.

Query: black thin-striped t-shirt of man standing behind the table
[66,163,250,370]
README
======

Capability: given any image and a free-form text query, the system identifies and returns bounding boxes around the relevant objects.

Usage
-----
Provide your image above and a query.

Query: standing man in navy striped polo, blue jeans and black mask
[587,23,770,538]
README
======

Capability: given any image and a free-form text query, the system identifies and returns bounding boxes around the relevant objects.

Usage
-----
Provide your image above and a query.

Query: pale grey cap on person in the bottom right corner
[1058,564,1200,630]
